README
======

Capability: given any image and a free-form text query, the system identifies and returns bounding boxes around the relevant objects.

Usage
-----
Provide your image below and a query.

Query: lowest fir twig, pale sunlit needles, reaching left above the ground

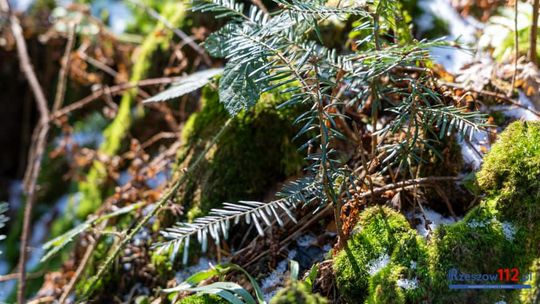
[153,178,320,264]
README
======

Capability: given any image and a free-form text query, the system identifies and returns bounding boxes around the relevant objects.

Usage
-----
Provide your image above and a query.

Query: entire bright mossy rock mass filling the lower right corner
[334,122,540,304]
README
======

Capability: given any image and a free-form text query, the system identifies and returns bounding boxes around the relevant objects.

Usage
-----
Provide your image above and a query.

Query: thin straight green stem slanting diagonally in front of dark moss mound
[85,117,233,296]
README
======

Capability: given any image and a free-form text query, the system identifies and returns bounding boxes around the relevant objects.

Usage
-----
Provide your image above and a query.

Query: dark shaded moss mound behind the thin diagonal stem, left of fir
[179,88,304,218]
